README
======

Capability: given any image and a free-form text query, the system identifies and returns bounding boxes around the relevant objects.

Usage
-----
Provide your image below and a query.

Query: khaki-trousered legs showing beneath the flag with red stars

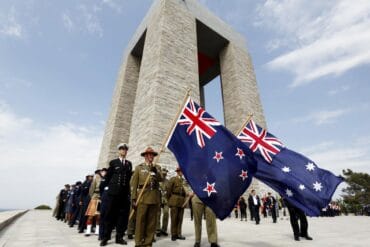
[191,195,219,247]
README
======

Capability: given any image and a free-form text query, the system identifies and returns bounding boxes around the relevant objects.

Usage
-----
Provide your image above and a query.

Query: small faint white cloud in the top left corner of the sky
[0,7,23,39]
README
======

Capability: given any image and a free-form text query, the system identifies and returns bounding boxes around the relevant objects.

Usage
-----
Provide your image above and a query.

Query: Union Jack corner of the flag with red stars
[178,97,221,148]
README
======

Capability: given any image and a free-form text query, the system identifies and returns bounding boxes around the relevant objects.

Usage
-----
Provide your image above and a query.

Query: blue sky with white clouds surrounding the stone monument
[0,0,370,208]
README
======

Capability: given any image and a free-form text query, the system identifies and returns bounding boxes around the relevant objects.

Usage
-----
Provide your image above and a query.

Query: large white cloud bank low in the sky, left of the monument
[0,103,103,208]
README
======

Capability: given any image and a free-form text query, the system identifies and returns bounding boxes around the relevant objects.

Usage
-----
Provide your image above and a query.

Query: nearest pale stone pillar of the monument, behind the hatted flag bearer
[129,0,199,166]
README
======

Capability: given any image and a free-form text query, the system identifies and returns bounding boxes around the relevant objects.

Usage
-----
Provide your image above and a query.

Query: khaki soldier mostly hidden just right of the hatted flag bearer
[157,169,169,237]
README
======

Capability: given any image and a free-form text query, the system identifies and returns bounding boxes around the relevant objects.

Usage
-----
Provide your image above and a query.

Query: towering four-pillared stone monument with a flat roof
[98,0,266,192]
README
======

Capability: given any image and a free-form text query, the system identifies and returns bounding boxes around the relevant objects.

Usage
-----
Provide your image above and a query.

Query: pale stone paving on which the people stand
[0,210,370,247]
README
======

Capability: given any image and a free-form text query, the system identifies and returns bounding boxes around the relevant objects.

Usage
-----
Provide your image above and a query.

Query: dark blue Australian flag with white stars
[238,120,343,216]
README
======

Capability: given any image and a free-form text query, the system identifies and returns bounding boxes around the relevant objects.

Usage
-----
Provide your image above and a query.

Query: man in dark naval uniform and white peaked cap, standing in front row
[100,143,132,246]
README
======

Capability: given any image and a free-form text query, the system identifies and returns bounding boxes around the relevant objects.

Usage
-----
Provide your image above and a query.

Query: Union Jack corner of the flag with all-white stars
[238,119,284,163]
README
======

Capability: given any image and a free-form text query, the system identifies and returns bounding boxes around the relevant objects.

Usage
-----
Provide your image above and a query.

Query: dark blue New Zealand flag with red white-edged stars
[167,97,256,220]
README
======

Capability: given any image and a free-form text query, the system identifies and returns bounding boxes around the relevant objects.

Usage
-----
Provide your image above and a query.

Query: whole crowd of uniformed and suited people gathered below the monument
[53,143,318,247]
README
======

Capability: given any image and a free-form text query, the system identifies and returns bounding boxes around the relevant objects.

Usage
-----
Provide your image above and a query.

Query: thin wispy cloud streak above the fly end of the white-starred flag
[293,109,350,125]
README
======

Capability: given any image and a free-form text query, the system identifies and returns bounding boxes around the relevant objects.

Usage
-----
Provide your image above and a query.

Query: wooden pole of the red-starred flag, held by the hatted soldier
[129,88,191,221]
